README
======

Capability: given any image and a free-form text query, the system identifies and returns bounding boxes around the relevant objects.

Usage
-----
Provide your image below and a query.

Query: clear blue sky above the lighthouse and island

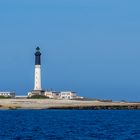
[0,0,140,101]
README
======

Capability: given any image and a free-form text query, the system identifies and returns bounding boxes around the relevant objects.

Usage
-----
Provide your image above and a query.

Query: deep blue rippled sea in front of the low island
[0,110,140,140]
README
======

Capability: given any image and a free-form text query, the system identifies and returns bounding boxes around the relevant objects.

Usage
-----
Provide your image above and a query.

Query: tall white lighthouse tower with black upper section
[34,47,42,91]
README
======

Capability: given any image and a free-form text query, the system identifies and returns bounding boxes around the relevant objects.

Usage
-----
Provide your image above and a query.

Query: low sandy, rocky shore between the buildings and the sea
[0,99,140,110]
